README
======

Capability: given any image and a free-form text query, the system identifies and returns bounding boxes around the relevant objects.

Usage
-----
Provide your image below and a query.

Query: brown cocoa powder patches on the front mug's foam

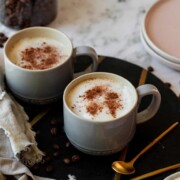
[81,86,123,118]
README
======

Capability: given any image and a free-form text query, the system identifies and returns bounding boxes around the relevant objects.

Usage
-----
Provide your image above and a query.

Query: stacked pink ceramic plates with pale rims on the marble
[140,0,180,71]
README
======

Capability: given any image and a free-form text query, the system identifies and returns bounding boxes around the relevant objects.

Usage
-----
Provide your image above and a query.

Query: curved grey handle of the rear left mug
[74,46,98,76]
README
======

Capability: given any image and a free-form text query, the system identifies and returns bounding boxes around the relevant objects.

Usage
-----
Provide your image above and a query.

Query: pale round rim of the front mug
[63,72,138,123]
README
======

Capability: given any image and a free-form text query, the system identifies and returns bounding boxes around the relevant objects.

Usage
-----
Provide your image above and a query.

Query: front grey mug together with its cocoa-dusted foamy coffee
[63,72,161,155]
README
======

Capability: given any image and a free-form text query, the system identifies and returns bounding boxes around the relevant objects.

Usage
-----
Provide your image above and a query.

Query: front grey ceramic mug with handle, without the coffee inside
[63,72,161,155]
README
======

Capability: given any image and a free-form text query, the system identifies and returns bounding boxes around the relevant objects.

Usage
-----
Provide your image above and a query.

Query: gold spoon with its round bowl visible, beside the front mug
[112,122,179,175]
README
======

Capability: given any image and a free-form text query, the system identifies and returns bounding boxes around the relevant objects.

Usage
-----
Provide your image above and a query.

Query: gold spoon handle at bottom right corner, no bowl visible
[130,163,180,180]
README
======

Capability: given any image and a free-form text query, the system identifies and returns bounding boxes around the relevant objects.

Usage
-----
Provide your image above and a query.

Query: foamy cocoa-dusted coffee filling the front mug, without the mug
[67,78,135,121]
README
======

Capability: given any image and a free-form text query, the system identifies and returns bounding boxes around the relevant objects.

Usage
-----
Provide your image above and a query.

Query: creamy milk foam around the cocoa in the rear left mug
[9,37,69,69]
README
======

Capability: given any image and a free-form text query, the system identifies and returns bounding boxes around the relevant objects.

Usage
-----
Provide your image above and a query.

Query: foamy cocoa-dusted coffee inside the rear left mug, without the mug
[9,37,68,70]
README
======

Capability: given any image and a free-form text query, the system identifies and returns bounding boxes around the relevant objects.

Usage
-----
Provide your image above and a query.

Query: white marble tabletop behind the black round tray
[0,0,180,96]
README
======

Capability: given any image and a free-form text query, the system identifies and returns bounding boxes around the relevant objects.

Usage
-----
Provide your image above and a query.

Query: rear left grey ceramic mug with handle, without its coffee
[4,27,98,104]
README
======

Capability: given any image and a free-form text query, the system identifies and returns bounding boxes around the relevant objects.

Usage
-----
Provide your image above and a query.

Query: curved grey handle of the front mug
[136,84,161,124]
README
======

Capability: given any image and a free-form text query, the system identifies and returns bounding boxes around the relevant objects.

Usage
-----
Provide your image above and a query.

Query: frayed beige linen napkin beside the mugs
[0,66,54,180]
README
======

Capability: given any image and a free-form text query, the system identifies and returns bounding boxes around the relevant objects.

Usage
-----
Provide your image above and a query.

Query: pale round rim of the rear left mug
[3,26,73,72]
